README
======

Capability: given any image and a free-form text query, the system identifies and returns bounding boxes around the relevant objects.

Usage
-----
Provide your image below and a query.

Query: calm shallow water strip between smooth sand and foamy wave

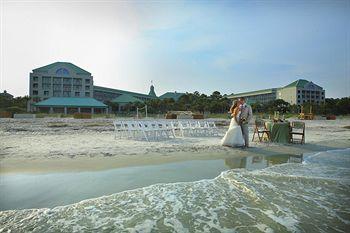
[0,155,302,211]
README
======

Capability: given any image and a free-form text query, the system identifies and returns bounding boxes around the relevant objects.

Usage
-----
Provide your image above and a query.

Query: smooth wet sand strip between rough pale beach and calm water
[0,139,350,175]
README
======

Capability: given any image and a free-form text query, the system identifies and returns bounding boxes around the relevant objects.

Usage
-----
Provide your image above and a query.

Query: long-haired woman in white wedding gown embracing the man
[221,100,244,147]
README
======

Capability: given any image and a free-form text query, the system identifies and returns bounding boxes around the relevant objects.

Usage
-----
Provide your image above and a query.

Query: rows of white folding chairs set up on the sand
[113,120,218,141]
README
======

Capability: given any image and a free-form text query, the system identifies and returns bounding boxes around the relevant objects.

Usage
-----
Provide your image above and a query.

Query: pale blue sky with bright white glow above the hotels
[0,0,350,97]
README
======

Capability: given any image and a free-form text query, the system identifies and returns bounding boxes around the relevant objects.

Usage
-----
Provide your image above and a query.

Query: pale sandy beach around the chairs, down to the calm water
[0,118,350,174]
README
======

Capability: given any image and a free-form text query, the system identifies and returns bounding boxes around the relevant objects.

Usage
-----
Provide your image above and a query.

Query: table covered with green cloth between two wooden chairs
[265,122,290,143]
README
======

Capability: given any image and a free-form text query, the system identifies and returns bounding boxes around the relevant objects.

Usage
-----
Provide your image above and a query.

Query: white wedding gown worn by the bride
[221,113,244,147]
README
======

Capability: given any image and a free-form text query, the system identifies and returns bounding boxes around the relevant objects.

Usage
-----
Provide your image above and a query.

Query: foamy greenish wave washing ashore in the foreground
[0,149,350,232]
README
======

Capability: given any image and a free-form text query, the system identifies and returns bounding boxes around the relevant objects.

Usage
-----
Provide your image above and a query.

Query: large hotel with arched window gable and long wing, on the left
[28,62,184,114]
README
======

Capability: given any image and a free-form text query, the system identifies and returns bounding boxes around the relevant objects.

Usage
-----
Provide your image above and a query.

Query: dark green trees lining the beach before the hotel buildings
[0,94,350,115]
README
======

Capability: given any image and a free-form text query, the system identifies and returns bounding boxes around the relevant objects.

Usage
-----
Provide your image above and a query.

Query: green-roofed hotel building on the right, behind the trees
[228,79,325,105]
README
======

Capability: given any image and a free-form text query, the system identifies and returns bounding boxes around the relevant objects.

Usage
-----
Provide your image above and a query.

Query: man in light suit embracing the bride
[238,97,253,148]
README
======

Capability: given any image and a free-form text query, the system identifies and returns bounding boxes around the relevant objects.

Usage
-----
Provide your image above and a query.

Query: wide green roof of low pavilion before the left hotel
[34,97,107,108]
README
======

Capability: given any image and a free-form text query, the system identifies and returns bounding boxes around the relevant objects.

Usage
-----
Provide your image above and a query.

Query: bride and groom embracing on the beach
[221,98,253,148]
